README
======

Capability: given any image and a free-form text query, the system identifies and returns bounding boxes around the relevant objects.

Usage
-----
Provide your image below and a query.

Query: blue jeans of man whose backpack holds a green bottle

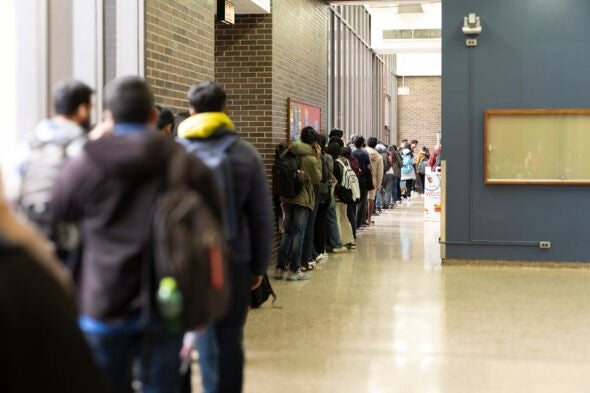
[85,329,183,393]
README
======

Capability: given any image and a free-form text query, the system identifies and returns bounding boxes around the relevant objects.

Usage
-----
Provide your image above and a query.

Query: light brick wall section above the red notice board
[272,0,329,143]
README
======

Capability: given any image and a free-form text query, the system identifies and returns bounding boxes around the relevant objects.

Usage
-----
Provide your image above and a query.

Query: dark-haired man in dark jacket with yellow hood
[178,82,273,392]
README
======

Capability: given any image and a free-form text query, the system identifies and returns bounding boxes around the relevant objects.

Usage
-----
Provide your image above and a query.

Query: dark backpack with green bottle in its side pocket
[152,146,230,330]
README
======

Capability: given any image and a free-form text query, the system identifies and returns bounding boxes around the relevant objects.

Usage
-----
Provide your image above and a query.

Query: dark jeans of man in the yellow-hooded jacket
[197,262,253,393]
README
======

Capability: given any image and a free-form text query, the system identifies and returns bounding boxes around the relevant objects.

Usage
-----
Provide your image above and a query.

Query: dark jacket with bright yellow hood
[178,112,273,274]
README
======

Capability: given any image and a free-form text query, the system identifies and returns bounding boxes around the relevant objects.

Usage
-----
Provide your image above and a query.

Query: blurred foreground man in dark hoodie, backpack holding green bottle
[51,76,221,392]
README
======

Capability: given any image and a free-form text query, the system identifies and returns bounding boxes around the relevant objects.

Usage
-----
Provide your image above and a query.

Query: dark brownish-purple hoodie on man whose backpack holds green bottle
[51,125,219,324]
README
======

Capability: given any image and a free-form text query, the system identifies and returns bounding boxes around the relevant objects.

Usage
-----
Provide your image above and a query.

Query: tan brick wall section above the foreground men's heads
[145,0,216,111]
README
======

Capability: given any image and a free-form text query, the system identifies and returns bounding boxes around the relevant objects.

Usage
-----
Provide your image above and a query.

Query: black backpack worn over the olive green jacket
[272,150,305,199]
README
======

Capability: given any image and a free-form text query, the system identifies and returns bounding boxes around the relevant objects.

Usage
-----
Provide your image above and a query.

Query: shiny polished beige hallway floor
[244,197,590,393]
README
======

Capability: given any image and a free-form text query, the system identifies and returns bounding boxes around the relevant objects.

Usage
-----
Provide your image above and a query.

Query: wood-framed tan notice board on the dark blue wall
[484,109,590,185]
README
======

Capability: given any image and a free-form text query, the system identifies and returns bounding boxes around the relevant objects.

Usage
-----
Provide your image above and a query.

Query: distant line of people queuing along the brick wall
[274,132,440,281]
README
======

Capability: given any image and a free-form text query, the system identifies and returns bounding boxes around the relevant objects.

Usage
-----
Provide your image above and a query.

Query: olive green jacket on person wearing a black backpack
[281,142,322,210]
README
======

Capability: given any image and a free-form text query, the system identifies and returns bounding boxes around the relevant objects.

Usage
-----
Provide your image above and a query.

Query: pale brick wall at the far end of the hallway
[397,76,441,150]
